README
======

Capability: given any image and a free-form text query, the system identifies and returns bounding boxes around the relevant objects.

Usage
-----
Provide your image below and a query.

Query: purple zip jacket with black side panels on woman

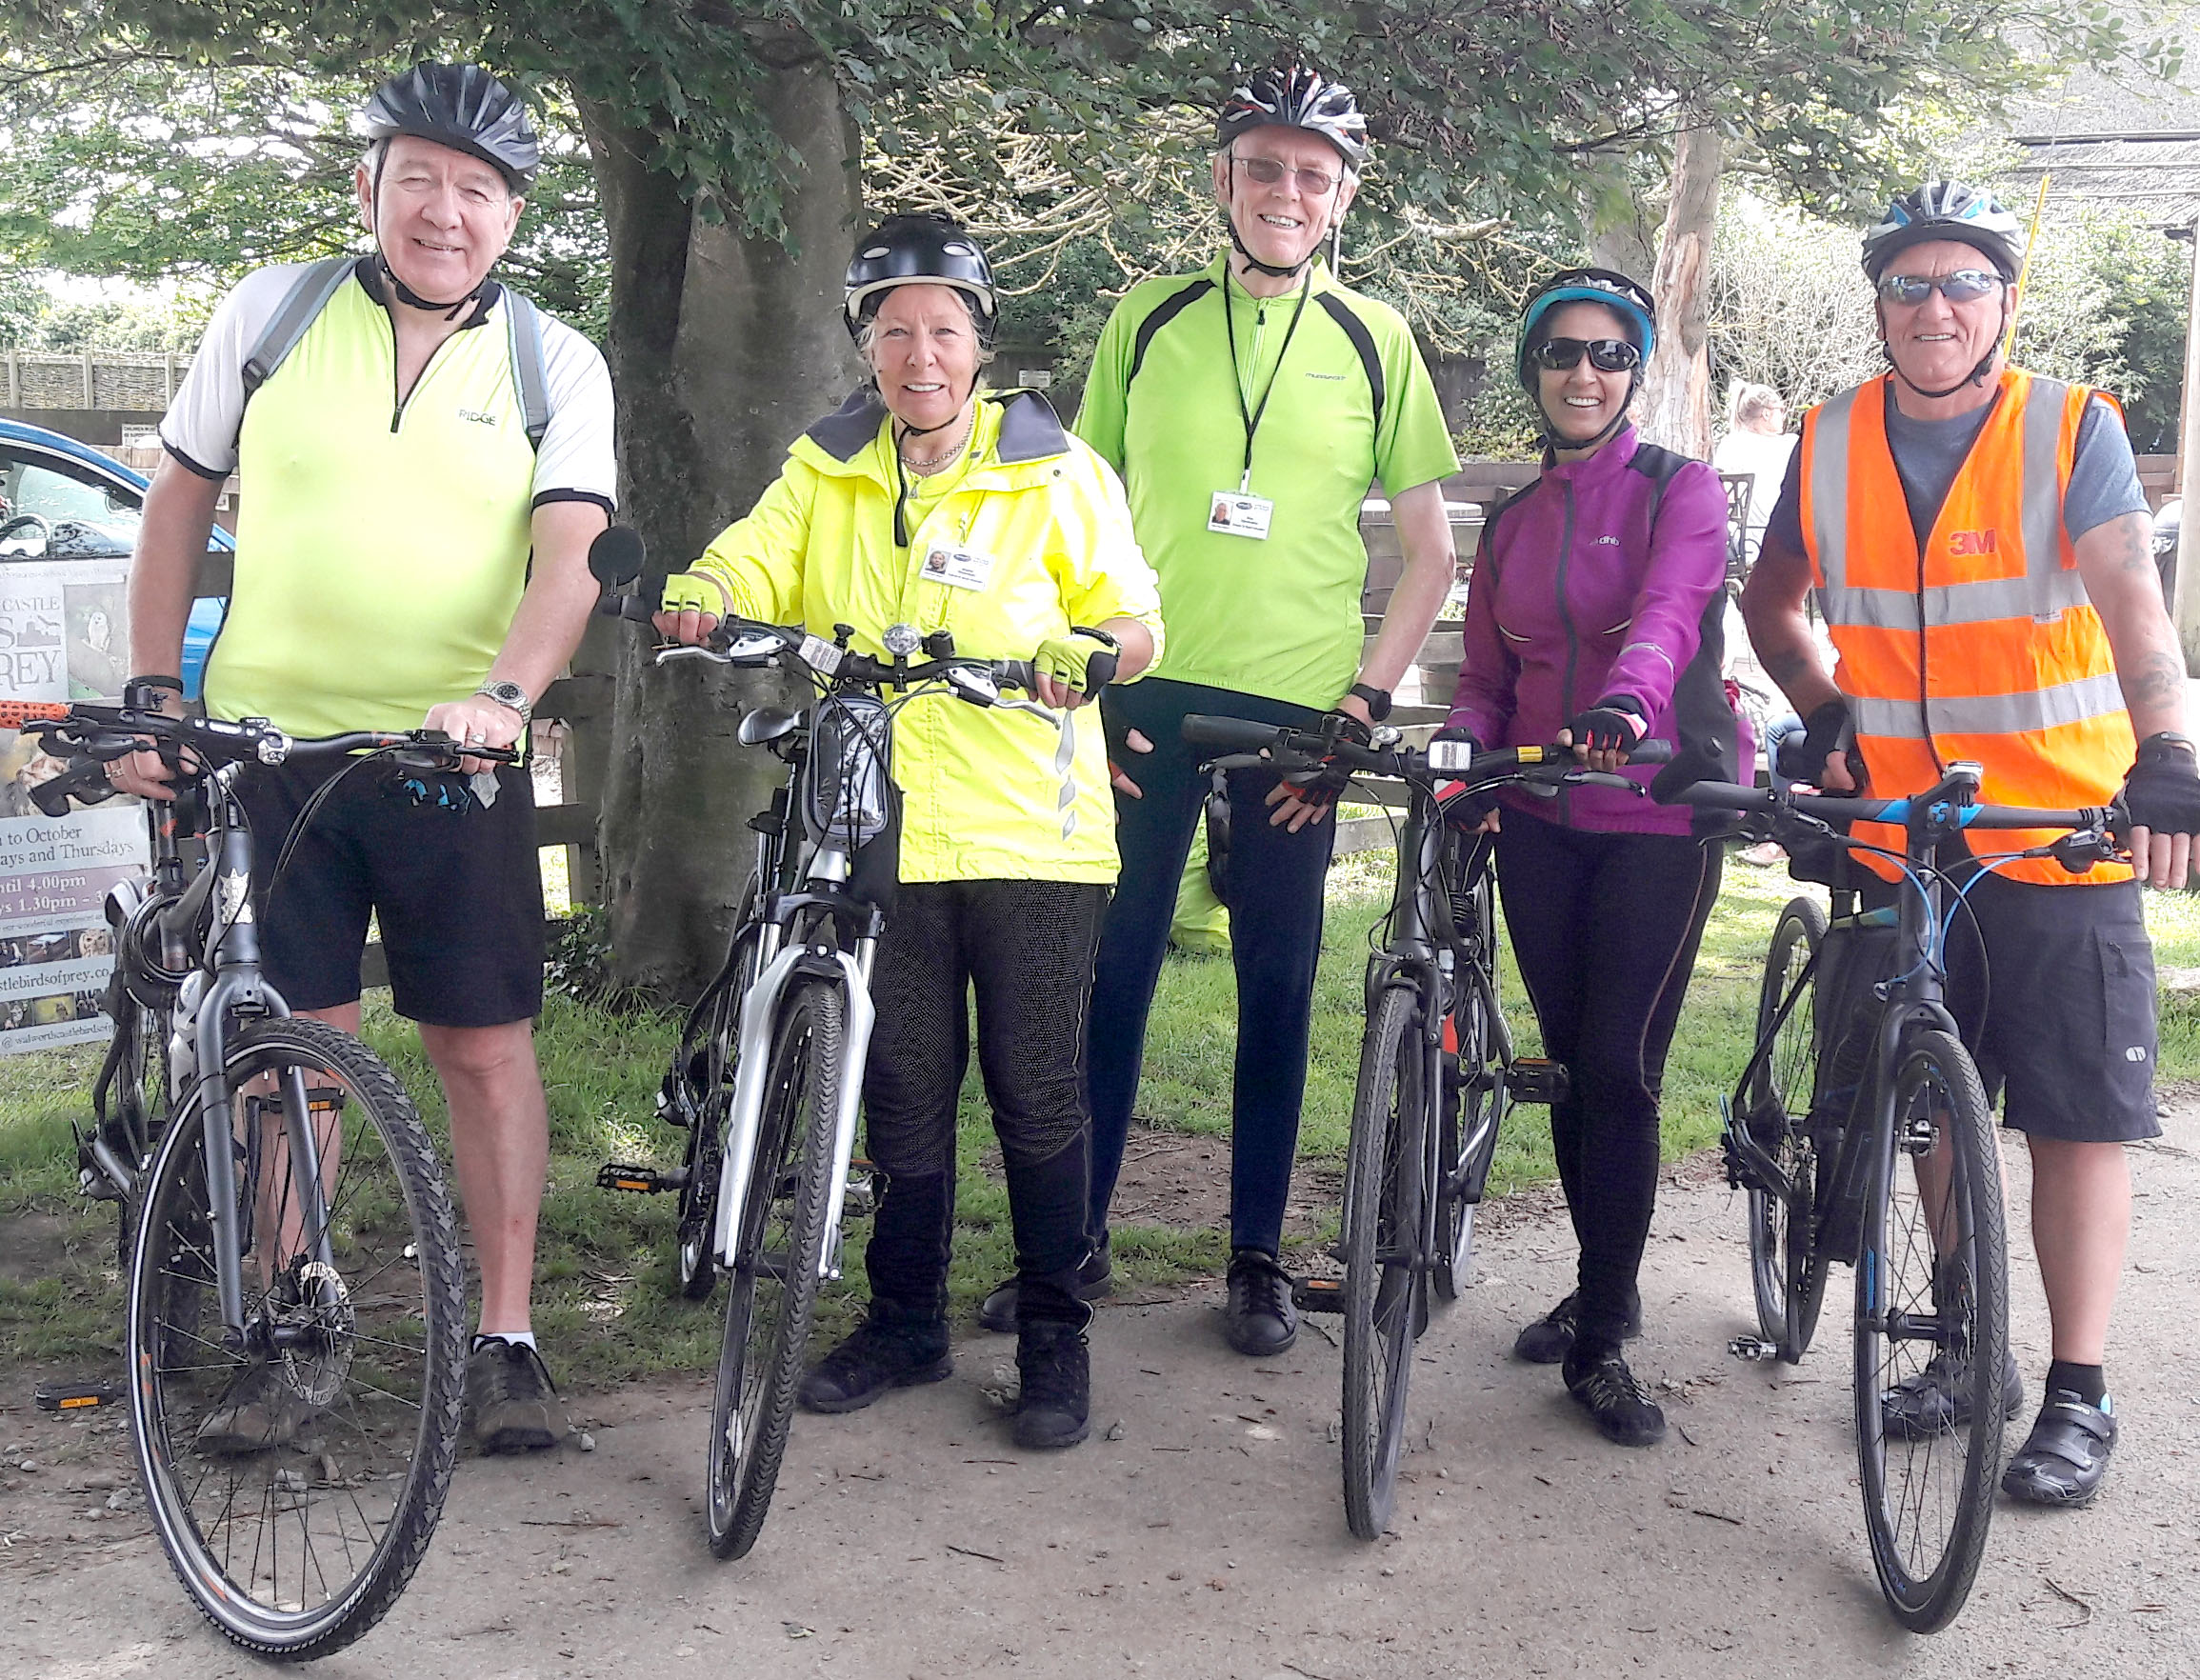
[1446,427,1755,833]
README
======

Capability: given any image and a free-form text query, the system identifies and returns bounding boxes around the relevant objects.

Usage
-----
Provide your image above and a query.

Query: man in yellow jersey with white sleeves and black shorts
[116,64,613,1451]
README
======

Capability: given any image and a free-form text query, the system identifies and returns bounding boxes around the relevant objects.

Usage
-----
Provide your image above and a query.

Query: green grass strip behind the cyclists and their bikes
[12,853,2200,1383]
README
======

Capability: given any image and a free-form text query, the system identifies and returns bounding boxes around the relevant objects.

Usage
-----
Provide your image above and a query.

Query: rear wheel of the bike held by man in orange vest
[1743,897,1826,1366]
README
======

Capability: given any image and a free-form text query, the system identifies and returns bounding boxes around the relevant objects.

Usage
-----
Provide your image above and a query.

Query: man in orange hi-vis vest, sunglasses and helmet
[1743,180,2200,1504]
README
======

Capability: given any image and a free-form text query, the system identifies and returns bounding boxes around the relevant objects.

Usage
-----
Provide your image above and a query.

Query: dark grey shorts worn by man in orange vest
[1866,867,2163,1144]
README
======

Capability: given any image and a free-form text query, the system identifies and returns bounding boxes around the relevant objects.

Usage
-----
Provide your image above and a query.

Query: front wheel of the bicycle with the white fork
[704,978,847,1557]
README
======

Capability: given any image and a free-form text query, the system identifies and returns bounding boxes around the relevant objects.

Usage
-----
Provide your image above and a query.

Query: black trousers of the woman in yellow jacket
[863,882,1109,1317]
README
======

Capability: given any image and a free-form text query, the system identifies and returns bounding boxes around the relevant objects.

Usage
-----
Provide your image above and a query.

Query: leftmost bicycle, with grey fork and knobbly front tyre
[0,702,490,1660]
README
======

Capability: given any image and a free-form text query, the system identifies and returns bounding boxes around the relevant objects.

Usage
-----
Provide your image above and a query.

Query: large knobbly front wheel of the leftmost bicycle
[128,1020,467,1660]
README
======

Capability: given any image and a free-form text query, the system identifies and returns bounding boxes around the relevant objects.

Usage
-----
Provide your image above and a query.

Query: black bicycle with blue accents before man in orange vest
[1674,763,2123,1634]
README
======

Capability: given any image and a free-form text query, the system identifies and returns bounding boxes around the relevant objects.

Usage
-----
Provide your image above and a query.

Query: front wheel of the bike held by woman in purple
[1342,985,1428,1539]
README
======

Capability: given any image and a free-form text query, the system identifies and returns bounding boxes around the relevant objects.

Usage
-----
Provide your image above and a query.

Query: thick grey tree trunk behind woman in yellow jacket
[581,35,863,998]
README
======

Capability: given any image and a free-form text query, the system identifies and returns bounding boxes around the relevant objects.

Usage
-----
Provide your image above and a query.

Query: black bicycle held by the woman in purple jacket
[1184,714,1672,1539]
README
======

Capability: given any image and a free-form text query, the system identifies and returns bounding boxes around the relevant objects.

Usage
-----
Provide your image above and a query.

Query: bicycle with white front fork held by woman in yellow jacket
[591,539,1090,1557]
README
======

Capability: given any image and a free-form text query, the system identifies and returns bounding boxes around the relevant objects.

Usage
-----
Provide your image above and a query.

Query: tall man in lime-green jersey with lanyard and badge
[986,64,1459,1354]
